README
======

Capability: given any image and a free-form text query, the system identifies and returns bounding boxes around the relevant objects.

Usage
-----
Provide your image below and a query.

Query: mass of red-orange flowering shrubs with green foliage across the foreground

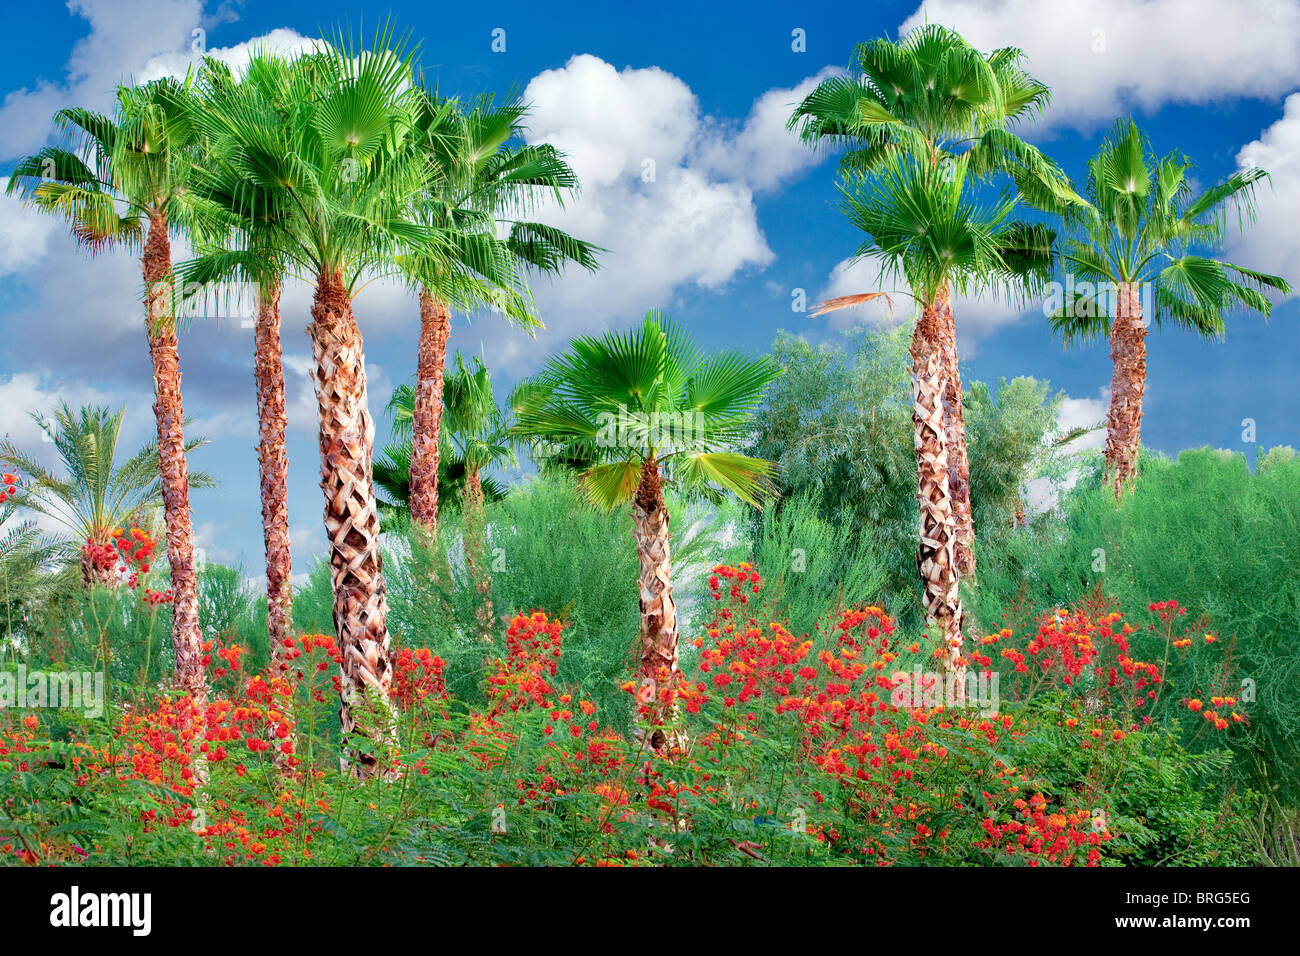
[0,564,1249,866]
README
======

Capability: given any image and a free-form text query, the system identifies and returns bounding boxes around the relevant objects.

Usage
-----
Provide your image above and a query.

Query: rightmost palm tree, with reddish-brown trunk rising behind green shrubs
[1050,120,1291,498]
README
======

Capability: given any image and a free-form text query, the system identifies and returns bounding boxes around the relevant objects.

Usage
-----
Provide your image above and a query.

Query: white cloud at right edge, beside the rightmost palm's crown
[1229,92,1300,295]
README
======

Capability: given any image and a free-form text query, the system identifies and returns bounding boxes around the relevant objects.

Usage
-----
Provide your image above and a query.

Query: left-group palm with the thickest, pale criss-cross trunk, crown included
[183,30,445,778]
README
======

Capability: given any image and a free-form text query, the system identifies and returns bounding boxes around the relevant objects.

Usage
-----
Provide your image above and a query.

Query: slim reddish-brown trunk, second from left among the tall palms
[254,282,294,665]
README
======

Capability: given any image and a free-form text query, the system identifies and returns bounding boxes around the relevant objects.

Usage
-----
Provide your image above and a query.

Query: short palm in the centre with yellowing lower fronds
[511,311,779,750]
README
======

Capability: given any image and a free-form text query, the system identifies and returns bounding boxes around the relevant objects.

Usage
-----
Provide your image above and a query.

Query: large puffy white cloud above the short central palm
[504,55,824,367]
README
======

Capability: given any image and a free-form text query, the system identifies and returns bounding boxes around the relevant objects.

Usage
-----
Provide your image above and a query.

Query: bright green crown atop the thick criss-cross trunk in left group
[180,33,441,290]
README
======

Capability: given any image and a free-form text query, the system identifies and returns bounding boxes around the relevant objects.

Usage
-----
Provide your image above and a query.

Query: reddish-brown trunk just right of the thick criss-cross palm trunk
[411,289,451,533]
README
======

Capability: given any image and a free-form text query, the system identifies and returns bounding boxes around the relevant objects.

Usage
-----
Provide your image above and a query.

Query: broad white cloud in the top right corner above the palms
[900,0,1300,130]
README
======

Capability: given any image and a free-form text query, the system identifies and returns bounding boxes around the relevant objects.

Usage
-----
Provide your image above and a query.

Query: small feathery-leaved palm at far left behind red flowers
[0,403,215,589]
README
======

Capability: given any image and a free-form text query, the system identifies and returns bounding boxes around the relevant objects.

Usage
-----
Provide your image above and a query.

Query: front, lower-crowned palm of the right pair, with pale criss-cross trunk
[841,155,1052,685]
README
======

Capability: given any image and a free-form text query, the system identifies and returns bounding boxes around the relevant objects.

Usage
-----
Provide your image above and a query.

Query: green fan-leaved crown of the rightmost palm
[1052,120,1291,342]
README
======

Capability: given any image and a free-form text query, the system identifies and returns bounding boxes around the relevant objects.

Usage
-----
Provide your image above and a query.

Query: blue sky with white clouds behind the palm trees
[0,0,1300,574]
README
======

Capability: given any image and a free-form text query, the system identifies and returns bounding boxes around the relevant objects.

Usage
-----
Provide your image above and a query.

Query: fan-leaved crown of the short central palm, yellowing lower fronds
[511,311,779,507]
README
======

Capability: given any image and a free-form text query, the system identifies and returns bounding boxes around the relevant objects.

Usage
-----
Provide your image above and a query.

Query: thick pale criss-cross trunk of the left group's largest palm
[307,272,397,779]
